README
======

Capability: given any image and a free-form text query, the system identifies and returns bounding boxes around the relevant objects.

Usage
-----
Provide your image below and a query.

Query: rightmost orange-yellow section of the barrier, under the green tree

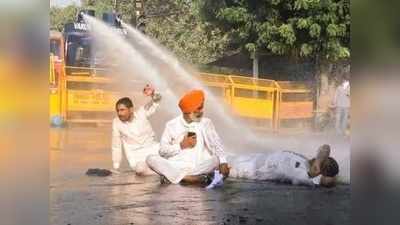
[276,81,314,129]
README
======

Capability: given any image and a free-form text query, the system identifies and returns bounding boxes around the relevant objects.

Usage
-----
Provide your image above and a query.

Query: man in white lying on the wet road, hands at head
[228,145,339,187]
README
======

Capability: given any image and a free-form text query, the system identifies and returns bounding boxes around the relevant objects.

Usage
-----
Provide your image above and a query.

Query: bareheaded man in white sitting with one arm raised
[112,85,161,175]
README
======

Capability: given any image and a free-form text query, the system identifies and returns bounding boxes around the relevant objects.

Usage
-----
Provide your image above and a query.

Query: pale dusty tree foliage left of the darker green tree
[145,0,228,65]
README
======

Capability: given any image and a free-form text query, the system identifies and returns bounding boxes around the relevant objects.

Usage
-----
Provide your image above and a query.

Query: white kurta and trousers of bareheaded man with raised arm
[112,103,160,170]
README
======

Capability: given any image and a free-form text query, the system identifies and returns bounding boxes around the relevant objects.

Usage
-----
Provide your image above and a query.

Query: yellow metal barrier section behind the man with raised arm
[63,67,144,123]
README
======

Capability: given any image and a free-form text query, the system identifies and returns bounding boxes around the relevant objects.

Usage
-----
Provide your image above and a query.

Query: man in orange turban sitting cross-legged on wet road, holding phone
[146,90,229,184]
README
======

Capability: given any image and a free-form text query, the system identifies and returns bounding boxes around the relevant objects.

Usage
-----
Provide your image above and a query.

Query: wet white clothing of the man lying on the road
[230,151,320,185]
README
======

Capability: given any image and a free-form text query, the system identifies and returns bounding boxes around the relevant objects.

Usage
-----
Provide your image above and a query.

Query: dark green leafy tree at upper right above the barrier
[196,0,350,78]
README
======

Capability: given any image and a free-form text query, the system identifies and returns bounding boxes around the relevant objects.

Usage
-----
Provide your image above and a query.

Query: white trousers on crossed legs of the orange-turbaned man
[146,155,219,184]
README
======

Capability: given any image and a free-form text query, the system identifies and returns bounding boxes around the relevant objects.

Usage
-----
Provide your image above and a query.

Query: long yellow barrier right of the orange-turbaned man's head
[198,73,314,131]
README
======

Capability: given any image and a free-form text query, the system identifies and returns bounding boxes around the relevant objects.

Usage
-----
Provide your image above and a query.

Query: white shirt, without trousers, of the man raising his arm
[112,103,159,164]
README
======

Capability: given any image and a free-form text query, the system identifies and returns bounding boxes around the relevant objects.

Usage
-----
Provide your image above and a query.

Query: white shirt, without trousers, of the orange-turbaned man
[160,115,226,166]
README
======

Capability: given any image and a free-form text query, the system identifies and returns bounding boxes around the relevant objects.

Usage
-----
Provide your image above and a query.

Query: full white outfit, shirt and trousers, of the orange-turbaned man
[147,116,226,184]
